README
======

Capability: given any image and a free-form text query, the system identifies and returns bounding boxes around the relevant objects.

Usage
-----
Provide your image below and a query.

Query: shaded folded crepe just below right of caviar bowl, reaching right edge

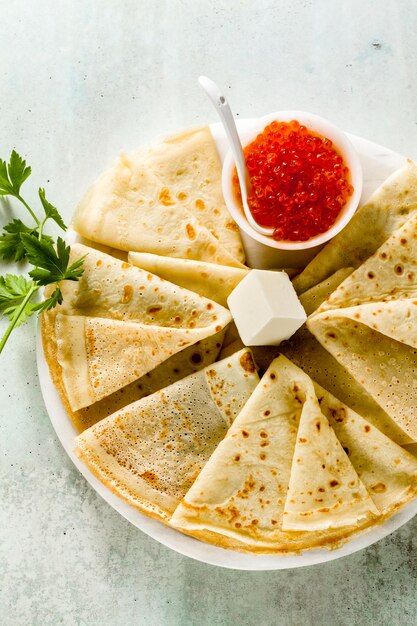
[293,161,417,294]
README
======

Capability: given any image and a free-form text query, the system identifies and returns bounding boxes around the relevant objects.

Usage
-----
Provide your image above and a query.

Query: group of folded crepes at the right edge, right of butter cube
[282,157,417,445]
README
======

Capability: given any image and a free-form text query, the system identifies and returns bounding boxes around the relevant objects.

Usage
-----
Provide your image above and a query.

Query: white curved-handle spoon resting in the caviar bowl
[198,76,274,236]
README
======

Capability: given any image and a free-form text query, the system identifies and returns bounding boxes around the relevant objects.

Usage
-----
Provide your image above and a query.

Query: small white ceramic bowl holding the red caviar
[222,111,363,267]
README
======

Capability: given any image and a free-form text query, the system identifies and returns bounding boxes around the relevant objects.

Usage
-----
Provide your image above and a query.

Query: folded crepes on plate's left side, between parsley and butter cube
[43,128,249,430]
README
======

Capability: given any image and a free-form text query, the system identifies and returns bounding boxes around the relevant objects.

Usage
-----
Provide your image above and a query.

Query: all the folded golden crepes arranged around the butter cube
[43,129,417,553]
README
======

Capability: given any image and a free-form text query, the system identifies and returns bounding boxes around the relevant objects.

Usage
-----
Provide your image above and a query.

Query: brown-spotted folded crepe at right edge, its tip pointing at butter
[307,214,417,441]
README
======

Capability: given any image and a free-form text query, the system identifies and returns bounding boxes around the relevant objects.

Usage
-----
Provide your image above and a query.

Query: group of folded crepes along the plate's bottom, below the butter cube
[76,350,417,553]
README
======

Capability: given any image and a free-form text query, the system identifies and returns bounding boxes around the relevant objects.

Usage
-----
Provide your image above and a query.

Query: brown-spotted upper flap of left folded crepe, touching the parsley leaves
[52,244,231,326]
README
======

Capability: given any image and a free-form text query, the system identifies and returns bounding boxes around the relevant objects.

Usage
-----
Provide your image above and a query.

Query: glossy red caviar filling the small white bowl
[233,120,353,241]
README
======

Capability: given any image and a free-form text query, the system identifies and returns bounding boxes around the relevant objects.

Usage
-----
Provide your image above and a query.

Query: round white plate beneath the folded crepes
[36,120,417,570]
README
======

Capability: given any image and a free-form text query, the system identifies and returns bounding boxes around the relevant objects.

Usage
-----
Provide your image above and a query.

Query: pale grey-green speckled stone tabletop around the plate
[0,0,417,626]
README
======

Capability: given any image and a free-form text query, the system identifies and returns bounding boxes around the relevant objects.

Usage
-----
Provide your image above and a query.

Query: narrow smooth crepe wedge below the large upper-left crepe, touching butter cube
[129,252,250,306]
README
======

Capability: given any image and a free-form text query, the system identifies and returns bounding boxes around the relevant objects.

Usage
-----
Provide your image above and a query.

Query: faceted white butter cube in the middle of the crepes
[227,270,307,346]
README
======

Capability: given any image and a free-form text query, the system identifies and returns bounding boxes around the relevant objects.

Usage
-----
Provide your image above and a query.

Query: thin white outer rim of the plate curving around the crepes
[36,129,417,571]
